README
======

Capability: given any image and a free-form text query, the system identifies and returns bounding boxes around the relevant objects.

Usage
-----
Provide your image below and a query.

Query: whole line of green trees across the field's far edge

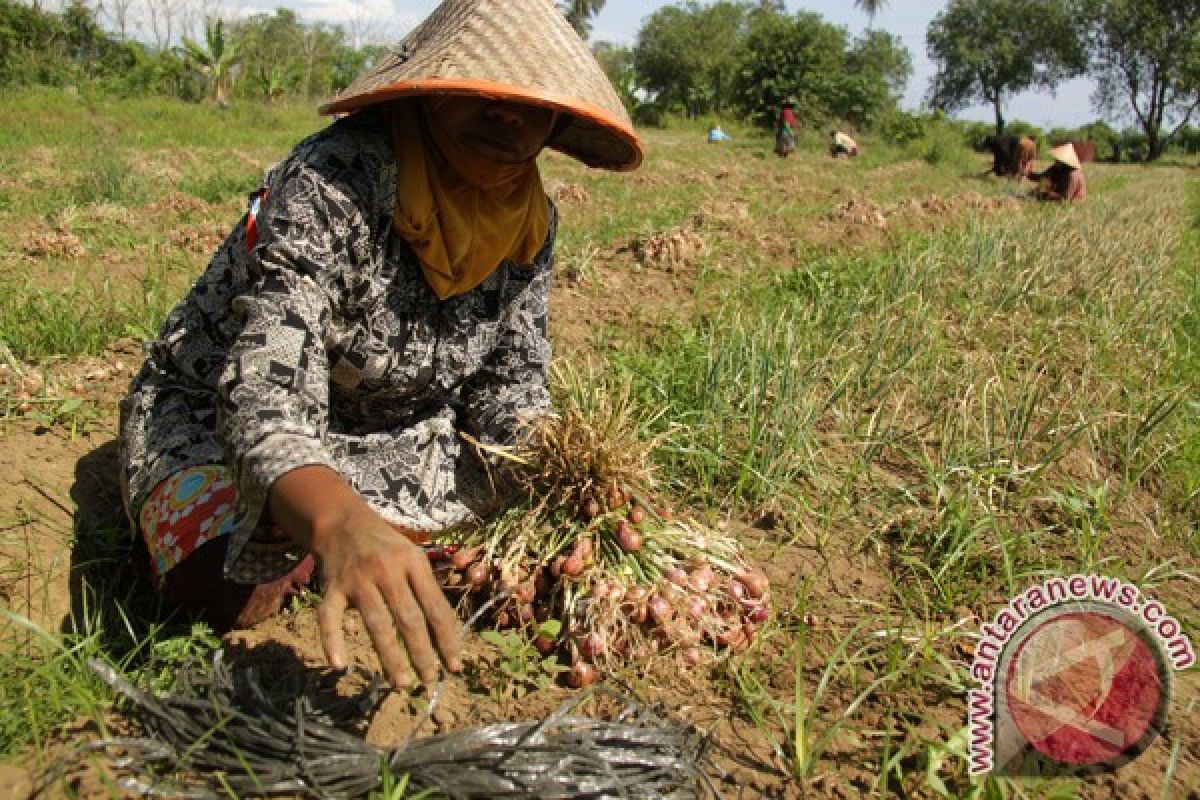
[0,0,1200,158]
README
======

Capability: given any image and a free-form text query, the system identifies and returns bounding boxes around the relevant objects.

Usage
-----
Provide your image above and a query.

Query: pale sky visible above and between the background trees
[239,0,1098,128]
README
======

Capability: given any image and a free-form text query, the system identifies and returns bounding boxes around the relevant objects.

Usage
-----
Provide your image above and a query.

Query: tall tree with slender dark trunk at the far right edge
[1082,0,1200,160]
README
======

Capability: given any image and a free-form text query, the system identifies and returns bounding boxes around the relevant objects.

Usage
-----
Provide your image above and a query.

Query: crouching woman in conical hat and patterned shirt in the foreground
[120,0,642,684]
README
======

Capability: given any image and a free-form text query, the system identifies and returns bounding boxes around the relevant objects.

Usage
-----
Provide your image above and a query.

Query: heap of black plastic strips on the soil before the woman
[89,651,719,800]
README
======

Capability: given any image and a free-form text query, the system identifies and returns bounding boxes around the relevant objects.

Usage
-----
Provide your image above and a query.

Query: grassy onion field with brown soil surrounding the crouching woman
[0,84,1200,800]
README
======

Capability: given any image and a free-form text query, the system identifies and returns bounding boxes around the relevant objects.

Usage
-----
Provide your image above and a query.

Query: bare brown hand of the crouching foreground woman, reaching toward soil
[312,510,462,686]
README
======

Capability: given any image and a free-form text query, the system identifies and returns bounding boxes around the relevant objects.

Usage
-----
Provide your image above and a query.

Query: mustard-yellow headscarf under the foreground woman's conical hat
[390,101,550,300]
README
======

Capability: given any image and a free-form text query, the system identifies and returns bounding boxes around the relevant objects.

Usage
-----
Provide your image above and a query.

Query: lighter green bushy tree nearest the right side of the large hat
[634,0,748,116]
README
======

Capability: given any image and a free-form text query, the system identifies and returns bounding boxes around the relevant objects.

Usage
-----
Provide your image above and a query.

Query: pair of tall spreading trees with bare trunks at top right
[926,0,1200,160]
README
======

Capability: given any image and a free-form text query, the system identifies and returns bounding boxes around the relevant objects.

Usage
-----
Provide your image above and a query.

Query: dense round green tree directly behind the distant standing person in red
[734,12,844,125]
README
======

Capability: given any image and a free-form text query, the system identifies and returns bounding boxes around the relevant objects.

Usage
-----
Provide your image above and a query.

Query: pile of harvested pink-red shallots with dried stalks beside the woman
[442,369,769,687]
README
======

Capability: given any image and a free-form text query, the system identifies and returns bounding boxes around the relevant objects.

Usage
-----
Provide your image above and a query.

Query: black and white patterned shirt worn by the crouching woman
[121,110,557,582]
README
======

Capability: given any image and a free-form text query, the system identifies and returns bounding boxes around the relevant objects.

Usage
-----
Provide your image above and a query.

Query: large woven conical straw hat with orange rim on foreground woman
[320,0,642,170]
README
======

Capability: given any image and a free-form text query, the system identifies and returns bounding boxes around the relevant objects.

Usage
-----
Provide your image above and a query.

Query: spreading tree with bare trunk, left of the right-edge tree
[925,0,1086,134]
